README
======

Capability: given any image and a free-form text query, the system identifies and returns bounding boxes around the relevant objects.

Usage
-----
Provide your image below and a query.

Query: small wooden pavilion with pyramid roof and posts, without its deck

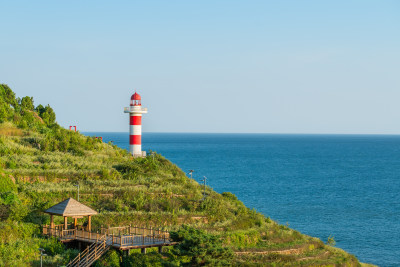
[44,197,97,232]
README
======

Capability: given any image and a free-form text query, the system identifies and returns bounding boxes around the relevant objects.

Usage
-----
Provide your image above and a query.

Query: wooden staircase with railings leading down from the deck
[67,235,111,267]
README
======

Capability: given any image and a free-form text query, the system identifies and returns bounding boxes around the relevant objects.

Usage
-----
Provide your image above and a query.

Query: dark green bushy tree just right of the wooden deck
[170,225,233,266]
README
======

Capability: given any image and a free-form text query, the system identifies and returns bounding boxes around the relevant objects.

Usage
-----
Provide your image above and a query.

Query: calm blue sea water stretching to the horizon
[86,133,400,266]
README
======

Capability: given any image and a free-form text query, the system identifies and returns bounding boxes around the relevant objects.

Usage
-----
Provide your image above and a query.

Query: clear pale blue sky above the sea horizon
[0,0,400,134]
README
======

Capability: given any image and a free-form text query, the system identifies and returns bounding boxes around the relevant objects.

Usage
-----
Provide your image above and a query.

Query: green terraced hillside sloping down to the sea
[0,85,360,266]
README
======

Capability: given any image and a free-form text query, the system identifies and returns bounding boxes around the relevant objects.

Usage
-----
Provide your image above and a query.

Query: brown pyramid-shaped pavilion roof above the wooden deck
[44,197,97,217]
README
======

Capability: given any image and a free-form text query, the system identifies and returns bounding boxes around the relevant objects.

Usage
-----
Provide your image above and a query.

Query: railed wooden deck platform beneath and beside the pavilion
[43,225,176,250]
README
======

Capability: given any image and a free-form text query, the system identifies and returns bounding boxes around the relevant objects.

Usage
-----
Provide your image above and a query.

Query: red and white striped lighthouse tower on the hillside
[124,92,147,157]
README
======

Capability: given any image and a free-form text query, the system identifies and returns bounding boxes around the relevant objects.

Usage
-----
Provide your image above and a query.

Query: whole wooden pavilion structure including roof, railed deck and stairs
[43,198,177,266]
